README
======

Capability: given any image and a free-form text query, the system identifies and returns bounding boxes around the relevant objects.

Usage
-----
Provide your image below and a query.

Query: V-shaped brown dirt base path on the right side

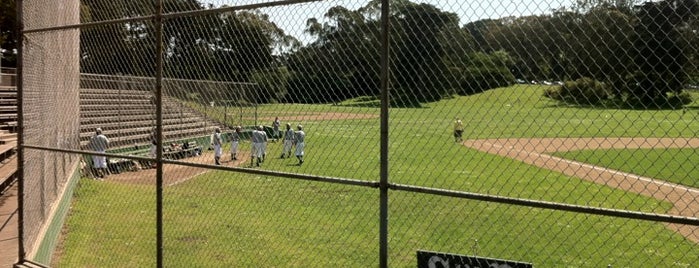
[463,138,699,243]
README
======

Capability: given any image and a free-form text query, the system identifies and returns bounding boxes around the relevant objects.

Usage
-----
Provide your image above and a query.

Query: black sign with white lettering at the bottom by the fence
[417,250,534,268]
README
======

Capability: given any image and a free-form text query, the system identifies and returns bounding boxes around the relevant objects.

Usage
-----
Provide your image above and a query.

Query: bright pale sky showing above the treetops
[200,0,574,44]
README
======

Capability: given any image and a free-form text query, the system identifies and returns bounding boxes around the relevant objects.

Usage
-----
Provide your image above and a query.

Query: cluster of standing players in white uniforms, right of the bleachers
[211,118,306,167]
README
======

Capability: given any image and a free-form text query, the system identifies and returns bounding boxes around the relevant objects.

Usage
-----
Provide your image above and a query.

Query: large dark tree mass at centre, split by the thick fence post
[287,0,458,106]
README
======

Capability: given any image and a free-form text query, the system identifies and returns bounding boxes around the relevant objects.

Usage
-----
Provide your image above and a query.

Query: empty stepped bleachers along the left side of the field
[0,68,225,193]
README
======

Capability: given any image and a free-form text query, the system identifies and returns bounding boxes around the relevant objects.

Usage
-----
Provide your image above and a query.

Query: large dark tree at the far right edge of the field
[544,0,698,108]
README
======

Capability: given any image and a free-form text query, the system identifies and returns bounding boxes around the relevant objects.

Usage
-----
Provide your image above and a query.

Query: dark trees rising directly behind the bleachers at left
[81,0,298,94]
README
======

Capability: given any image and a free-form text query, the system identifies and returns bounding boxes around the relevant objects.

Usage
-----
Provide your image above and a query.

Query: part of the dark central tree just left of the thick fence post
[286,3,379,103]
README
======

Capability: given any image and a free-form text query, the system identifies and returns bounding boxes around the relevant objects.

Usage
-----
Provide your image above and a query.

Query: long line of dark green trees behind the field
[0,0,699,106]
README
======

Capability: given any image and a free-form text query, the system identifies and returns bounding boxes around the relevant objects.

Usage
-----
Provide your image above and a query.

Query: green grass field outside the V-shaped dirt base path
[56,86,699,267]
